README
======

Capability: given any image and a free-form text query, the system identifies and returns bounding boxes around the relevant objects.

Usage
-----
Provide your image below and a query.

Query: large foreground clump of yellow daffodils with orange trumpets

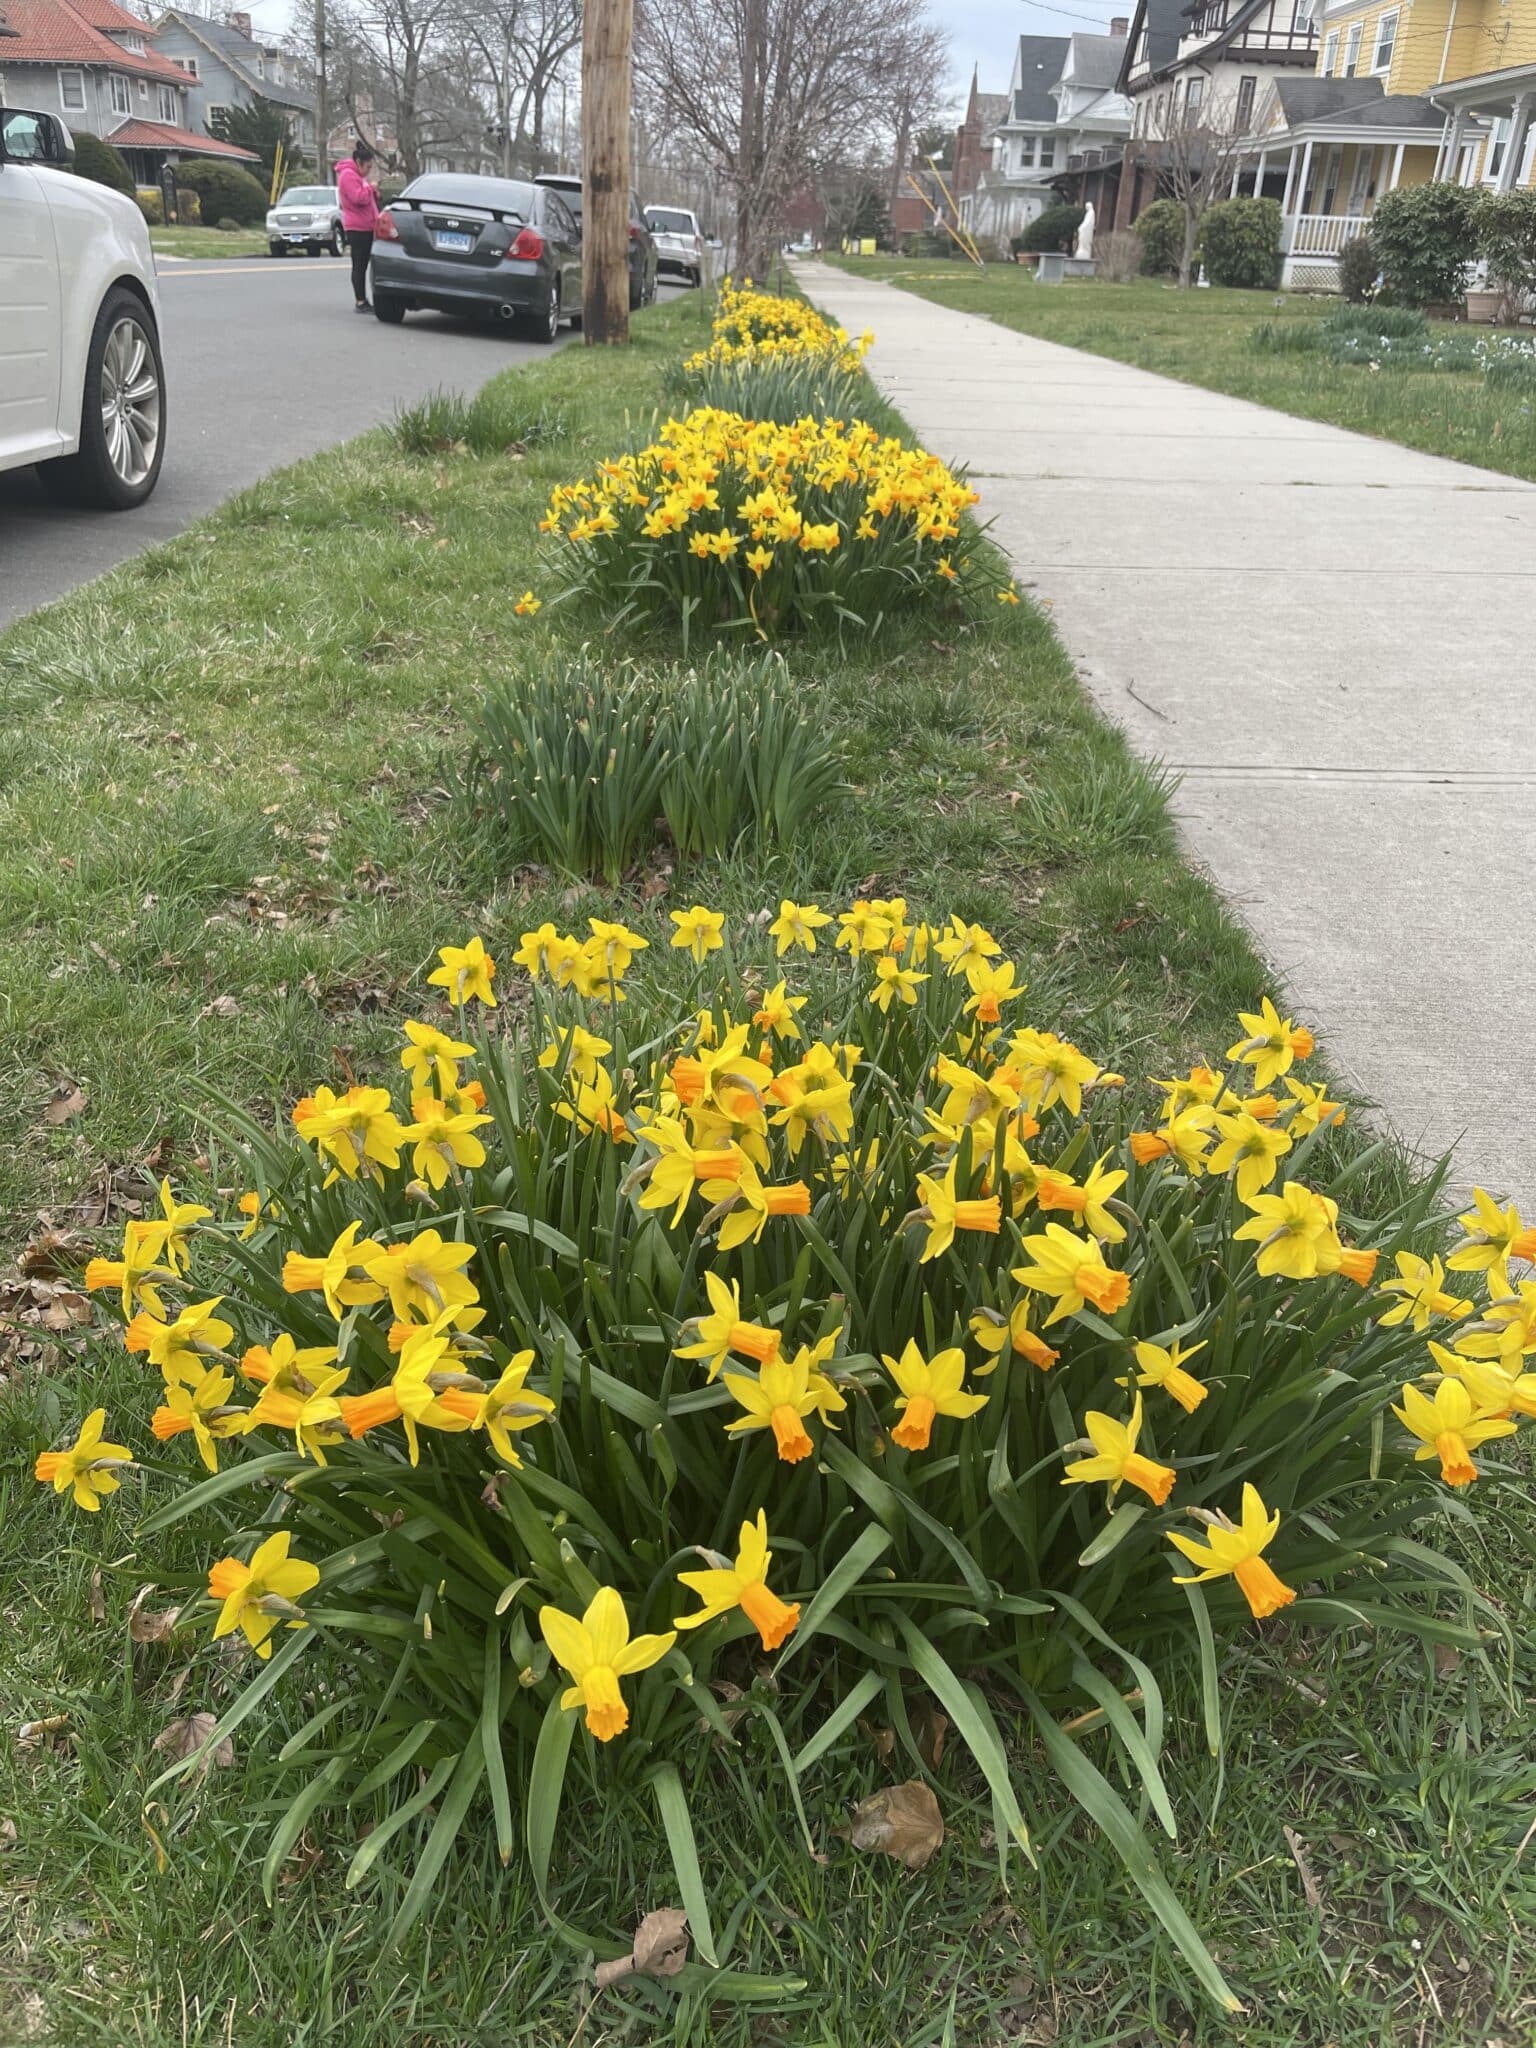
[48,933,1536,2005]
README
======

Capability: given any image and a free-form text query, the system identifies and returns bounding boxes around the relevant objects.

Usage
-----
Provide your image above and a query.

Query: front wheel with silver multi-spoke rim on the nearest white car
[37,285,166,512]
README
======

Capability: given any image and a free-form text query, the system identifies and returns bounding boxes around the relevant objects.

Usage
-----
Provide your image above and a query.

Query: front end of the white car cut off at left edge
[0,106,166,512]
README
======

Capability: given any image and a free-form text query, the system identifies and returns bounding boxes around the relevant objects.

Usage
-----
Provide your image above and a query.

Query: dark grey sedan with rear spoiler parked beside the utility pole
[373,172,582,342]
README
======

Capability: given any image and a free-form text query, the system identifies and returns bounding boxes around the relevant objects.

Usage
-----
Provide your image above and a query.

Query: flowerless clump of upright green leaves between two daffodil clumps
[465,647,842,883]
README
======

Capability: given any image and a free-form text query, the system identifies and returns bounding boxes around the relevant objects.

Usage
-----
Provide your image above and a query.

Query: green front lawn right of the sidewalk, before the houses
[827,256,1536,481]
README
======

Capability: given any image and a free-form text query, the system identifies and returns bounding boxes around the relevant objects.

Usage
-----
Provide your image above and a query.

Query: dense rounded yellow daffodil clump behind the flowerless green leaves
[541,408,981,638]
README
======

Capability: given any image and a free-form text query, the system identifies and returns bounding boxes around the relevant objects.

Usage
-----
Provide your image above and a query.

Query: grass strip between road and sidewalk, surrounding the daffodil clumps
[0,280,1536,2048]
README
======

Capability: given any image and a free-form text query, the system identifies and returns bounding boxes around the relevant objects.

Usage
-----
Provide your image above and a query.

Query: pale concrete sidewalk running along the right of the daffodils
[797,264,1536,1208]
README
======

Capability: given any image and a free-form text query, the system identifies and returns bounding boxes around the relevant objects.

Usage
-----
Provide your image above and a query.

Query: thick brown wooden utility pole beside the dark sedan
[582,0,635,348]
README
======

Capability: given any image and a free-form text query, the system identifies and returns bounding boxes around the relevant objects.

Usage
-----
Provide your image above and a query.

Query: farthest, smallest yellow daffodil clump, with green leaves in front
[666,279,874,426]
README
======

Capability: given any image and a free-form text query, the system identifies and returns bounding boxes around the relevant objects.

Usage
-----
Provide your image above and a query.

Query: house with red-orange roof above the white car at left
[0,0,256,184]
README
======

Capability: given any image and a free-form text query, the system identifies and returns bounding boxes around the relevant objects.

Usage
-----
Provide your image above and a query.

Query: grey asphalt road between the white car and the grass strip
[0,256,684,627]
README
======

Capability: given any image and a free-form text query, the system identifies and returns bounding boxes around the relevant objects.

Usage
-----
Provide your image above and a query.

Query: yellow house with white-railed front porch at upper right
[1243,0,1536,289]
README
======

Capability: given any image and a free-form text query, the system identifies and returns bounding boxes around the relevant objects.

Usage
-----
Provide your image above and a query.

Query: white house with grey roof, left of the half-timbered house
[961,18,1130,240]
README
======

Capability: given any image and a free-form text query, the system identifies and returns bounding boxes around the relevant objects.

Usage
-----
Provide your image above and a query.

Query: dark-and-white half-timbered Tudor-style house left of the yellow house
[1114,0,1323,227]
